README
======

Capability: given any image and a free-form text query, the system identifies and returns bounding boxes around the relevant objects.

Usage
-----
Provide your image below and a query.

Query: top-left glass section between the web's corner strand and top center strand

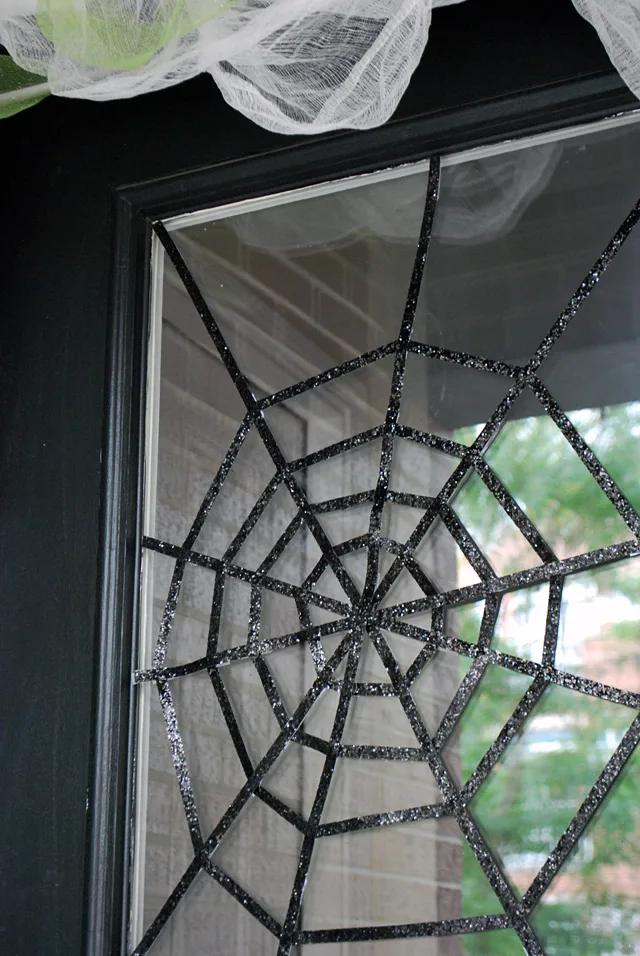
[176,172,427,393]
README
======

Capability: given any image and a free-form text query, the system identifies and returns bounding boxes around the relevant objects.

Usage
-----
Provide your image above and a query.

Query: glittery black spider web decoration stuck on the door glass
[134,159,640,956]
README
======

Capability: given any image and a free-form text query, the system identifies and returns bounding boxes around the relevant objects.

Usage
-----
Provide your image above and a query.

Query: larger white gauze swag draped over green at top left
[0,0,461,133]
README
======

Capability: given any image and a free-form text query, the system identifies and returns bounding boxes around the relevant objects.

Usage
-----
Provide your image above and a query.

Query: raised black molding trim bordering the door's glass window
[91,71,636,956]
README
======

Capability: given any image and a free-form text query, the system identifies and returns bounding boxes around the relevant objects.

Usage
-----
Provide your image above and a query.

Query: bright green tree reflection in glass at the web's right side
[457,403,640,956]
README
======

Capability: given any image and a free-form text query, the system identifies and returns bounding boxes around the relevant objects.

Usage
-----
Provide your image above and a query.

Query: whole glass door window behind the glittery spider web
[133,117,640,956]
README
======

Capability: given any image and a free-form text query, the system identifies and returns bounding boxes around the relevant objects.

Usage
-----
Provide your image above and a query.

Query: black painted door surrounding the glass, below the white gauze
[0,0,635,956]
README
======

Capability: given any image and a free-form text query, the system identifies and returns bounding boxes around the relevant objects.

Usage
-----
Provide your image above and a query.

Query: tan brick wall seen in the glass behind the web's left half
[135,229,462,956]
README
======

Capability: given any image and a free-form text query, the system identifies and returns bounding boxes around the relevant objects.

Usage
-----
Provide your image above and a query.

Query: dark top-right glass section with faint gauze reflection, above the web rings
[416,124,640,362]
